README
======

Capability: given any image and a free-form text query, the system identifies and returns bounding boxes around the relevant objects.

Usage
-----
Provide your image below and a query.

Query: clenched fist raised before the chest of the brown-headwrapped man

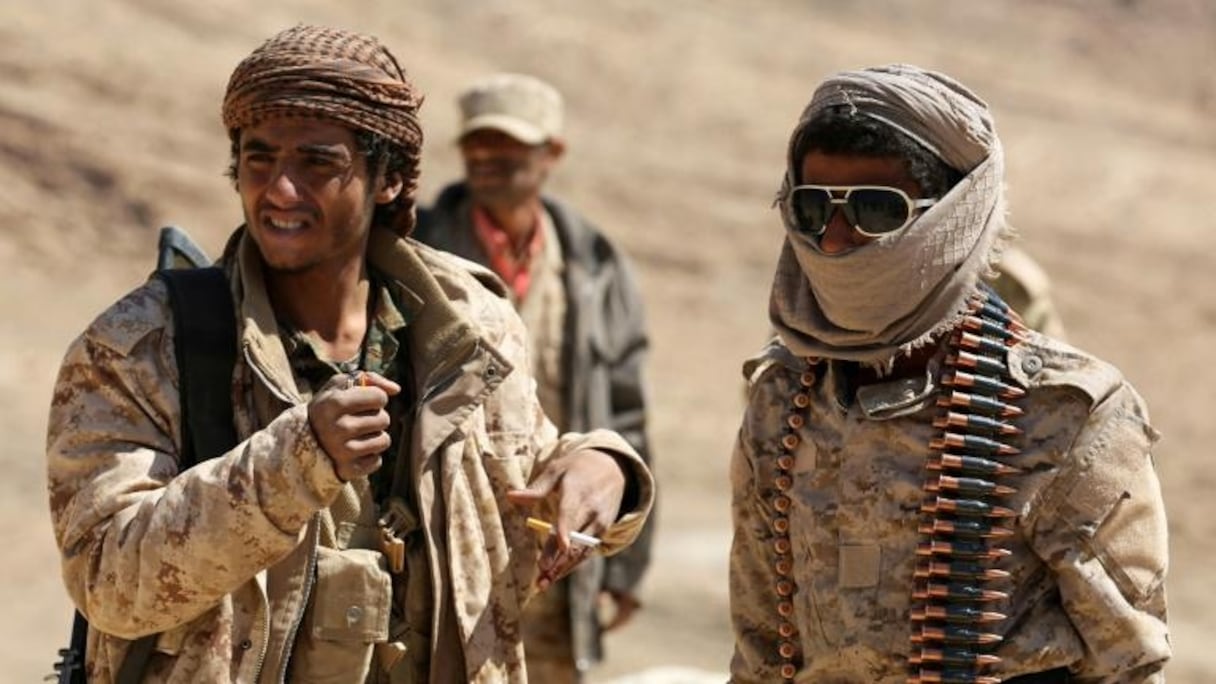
[308,371,401,482]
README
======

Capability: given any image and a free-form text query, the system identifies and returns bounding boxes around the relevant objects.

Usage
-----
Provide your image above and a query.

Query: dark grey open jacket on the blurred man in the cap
[415,183,654,668]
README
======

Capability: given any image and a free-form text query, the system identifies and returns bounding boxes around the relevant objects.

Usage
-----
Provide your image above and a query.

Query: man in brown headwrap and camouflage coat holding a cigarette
[47,26,653,683]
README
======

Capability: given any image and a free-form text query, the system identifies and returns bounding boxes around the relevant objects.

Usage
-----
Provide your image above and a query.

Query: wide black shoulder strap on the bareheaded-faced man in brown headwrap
[156,267,237,470]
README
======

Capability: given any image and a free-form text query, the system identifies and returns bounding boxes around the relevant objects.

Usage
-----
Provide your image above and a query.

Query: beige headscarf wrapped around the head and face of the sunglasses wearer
[770,65,1006,370]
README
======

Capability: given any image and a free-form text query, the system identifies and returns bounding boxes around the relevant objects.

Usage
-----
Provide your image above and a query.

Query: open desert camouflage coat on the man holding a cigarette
[47,230,653,683]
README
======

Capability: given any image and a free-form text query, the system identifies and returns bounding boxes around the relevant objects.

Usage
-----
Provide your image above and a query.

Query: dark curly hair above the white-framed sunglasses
[794,105,964,197]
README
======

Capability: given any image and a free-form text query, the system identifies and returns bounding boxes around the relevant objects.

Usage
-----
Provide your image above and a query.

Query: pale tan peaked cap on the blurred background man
[460,73,562,145]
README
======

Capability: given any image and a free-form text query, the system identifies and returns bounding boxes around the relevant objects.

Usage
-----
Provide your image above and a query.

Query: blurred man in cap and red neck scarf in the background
[416,74,653,684]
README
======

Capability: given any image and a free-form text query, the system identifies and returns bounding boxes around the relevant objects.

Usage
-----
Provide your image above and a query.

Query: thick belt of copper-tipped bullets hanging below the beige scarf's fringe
[908,287,1025,684]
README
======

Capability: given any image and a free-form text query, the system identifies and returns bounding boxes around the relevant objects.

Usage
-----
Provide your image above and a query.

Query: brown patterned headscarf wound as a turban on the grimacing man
[223,26,422,232]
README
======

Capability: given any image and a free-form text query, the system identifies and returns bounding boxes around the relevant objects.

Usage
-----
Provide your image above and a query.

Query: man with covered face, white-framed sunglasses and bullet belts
[731,65,1170,684]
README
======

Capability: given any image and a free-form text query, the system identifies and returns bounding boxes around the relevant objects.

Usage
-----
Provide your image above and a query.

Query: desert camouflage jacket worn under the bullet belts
[731,333,1170,684]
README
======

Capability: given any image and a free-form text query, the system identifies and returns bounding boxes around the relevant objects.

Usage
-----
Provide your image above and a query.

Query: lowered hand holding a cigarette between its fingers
[507,449,625,590]
